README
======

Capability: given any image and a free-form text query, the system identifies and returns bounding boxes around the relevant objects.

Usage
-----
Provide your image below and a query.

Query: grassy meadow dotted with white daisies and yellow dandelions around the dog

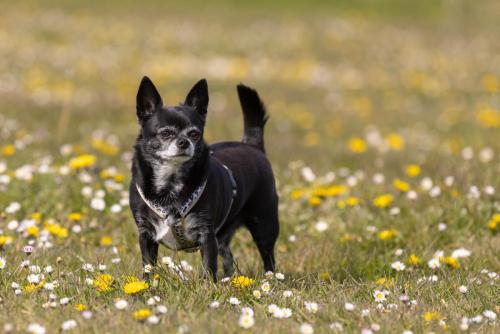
[0,0,500,334]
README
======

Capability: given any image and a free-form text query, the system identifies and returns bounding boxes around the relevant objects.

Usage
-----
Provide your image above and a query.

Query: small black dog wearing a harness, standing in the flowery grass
[130,77,279,280]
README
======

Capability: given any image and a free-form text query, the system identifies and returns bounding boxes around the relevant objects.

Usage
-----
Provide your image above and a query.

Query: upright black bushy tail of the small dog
[238,84,268,152]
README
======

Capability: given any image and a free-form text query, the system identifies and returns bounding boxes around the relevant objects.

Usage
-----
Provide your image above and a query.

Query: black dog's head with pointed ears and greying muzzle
[137,77,208,165]
